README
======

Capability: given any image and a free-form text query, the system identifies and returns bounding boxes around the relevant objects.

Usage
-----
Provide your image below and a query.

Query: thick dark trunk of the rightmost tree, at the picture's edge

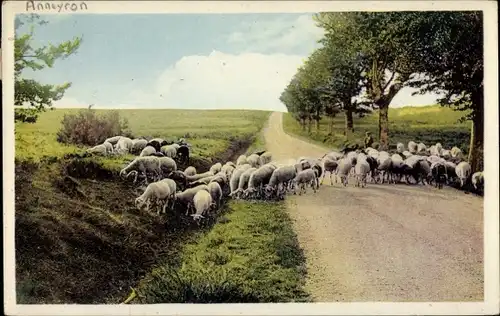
[468,92,484,173]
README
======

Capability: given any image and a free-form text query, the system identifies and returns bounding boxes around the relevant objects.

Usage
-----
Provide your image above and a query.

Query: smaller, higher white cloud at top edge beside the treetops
[227,15,324,53]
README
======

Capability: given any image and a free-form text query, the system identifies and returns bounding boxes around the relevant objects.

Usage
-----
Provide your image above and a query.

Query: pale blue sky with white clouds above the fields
[18,13,436,112]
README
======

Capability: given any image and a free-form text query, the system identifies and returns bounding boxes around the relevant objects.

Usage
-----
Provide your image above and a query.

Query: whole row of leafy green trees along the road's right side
[282,11,484,170]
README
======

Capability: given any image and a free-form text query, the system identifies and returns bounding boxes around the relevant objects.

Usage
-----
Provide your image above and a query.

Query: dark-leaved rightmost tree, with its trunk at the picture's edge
[407,11,484,172]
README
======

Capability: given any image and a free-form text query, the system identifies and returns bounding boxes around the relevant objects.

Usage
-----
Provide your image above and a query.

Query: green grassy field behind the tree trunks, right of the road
[283,105,470,152]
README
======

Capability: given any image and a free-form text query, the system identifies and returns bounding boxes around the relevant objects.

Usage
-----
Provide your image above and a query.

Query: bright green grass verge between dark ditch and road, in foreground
[133,201,309,304]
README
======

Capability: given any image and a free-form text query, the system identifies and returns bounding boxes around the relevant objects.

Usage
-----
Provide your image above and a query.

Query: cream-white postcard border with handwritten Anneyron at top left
[2,1,500,315]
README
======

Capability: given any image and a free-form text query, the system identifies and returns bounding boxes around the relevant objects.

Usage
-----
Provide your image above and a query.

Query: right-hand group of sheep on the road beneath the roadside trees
[322,141,484,191]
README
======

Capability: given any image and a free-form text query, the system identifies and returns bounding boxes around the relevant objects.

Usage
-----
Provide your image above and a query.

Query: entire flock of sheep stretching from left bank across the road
[89,136,484,223]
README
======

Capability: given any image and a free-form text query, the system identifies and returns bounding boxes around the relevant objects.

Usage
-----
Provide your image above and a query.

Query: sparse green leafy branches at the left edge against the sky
[14,14,82,123]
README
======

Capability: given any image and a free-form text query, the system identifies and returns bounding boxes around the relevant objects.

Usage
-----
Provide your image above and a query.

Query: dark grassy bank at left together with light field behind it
[15,110,286,304]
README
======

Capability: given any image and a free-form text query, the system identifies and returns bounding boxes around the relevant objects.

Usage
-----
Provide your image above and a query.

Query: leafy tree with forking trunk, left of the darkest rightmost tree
[315,12,413,149]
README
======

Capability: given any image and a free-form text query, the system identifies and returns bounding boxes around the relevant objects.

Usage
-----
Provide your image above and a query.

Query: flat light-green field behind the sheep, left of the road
[15,109,270,164]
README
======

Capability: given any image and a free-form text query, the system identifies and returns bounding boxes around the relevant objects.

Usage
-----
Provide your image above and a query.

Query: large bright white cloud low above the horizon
[127,51,303,111]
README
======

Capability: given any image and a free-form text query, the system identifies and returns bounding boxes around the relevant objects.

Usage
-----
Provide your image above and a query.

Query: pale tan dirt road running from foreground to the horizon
[264,112,484,302]
